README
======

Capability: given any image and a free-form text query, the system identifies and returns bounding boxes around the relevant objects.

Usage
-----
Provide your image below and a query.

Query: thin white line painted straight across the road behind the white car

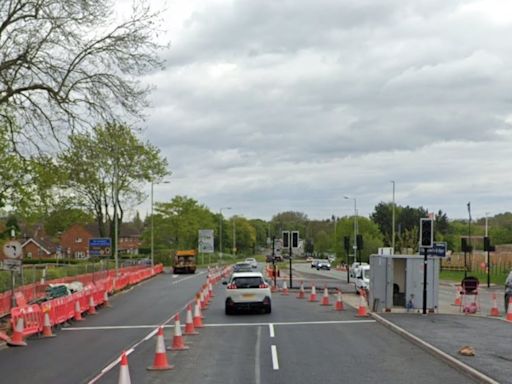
[61,320,375,337]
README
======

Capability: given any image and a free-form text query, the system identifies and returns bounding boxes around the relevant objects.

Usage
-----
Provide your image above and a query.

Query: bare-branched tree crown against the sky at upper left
[0,0,162,151]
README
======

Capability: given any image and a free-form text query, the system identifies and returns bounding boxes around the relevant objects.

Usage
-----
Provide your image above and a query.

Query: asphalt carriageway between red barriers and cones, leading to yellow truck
[0,271,210,384]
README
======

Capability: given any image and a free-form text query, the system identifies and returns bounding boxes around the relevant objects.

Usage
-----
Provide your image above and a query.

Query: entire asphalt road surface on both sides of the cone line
[0,270,484,384]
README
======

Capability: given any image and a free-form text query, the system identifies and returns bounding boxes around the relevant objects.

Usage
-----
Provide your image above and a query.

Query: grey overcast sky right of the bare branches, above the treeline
[131,0,512,220]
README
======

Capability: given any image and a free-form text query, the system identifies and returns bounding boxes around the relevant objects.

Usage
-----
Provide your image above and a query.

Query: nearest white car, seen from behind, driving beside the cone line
[222,272,272,315]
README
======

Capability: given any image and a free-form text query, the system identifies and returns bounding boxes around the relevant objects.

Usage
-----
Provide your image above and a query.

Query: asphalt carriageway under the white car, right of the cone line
[95,268,472,384]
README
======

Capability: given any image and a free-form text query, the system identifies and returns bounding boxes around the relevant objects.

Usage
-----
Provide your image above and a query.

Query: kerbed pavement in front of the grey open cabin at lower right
[343,294,512,384]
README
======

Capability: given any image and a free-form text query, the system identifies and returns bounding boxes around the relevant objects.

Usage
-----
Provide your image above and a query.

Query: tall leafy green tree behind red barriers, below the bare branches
[58,123,168,246]
